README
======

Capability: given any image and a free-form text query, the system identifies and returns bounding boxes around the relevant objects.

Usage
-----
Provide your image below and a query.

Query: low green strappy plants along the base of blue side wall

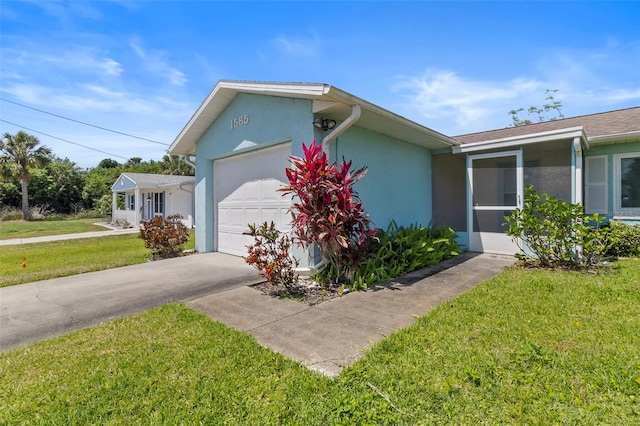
[317,221,460,290]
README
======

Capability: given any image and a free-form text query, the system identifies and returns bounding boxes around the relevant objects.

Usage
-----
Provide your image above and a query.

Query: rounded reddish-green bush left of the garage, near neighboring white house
[138,214,189,259]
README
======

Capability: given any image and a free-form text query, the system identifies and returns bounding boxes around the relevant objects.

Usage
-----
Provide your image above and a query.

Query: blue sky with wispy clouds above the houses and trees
[0,0,640,167]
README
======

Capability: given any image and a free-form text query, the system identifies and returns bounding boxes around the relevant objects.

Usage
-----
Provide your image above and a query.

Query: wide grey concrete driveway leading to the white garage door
[0,253,261,350]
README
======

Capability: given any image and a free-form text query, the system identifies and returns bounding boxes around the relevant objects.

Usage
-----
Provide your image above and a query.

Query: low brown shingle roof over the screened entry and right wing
[454,106,640,144]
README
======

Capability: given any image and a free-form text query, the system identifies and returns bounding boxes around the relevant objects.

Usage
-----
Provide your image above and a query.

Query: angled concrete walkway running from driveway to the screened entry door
[187,253,514,377]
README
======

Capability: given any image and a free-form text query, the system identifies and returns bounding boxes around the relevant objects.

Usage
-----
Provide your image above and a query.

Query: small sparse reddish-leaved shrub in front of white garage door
[244,222,298,293]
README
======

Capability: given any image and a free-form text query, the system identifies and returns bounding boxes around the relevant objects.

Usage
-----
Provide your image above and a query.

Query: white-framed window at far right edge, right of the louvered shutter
[613,152,640,217]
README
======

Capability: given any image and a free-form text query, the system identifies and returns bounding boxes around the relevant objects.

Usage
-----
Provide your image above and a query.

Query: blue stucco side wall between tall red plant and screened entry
[329,126,432,229]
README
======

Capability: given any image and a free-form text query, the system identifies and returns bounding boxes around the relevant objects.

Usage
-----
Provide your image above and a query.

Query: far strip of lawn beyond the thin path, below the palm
[0,218,109,240]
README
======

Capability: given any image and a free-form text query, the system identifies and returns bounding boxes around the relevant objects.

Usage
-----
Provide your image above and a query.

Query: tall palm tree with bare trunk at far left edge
[0,130,51,220]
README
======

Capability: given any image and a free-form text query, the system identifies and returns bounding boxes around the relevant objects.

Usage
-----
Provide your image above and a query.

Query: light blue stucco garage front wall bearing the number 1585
[195,93,314,252]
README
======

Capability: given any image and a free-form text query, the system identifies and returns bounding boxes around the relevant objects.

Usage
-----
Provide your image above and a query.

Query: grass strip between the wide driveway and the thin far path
[0,231,195,287]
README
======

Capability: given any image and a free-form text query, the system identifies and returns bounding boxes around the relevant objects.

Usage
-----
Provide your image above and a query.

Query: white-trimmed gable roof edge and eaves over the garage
[168,80,458,155]
